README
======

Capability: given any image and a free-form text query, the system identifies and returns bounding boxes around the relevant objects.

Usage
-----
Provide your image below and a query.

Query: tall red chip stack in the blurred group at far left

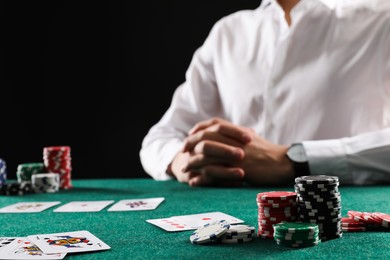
[43,146,72,189]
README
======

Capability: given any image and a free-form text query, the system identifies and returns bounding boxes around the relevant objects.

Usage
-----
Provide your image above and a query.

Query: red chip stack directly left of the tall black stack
[256,191,297,238]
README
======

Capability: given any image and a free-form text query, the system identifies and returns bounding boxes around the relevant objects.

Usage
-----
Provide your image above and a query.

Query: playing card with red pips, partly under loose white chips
[146,212,244,232]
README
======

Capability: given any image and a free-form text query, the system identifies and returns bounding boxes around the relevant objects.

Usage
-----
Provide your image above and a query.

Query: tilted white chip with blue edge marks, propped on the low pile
[190,220,230,244]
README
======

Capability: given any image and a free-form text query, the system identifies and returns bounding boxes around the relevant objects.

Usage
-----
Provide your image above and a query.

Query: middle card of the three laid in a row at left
[53,200,114,212]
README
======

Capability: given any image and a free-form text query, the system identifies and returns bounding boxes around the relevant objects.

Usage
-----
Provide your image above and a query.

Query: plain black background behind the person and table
[0,0,260,179]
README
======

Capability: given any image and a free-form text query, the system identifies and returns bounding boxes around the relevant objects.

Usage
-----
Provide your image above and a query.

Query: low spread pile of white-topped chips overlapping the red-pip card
[190,220,255,245]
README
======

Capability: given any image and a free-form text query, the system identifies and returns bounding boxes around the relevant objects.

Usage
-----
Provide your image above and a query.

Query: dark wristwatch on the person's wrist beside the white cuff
[286,143,310,177]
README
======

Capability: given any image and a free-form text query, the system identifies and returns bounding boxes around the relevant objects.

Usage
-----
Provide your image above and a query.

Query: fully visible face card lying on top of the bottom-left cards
[27,230,111,254]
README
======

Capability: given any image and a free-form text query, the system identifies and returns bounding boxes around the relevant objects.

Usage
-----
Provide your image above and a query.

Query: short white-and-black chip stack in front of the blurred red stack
[32,173,60,193]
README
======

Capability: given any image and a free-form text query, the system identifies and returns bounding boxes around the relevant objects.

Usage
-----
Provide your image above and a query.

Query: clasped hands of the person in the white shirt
[176,118,294,186]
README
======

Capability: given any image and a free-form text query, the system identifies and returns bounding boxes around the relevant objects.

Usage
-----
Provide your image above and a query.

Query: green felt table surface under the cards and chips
[0,179,390,259]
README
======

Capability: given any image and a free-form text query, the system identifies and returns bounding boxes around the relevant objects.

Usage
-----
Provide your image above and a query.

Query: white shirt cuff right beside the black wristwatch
[302,139,353,185]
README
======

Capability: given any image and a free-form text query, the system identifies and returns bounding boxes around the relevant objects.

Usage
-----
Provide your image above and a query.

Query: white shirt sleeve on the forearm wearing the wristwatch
[303,128,390,185]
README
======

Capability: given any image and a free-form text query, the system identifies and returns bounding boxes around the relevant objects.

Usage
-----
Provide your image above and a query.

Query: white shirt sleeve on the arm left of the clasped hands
[139,20,221,180]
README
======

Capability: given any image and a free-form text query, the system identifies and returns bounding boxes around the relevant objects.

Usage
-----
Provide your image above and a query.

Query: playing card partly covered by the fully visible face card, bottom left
[0,237,66,259]
